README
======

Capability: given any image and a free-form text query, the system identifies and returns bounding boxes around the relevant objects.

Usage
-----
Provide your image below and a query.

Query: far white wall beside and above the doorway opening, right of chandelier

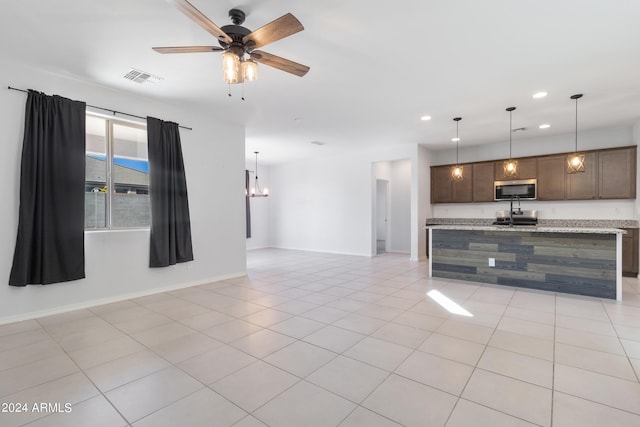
[269,144,416,256]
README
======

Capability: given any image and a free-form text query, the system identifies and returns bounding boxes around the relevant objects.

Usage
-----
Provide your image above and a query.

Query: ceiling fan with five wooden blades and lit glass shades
[153,0,309,84]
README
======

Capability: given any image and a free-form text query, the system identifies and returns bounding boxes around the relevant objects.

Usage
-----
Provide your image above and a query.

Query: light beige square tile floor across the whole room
[0,249,640,427]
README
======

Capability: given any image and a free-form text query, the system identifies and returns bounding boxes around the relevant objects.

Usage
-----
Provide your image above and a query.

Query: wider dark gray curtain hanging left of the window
[9,90,86,286]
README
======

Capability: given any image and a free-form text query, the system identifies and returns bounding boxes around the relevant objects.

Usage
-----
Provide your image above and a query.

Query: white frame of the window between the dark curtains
[84,111,151,232]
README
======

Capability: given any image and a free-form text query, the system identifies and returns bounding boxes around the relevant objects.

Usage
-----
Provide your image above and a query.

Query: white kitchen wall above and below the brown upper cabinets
[431,125,640,219]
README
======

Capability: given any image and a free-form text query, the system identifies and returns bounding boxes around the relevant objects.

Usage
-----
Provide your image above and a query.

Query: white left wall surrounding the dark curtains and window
[0,62,246,323]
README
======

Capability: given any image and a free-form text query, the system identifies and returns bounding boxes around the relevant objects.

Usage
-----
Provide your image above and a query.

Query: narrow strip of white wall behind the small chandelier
[246,159,274,249]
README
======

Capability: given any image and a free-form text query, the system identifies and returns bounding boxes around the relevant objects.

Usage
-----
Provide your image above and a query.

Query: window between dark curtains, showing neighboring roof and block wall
[84,115,151,230]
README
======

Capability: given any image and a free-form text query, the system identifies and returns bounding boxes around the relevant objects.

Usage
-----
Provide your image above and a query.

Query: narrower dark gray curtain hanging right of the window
[147,117,193,267]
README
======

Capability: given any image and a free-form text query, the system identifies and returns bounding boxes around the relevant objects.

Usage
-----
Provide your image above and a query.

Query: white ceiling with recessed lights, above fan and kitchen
[0,0,640,163]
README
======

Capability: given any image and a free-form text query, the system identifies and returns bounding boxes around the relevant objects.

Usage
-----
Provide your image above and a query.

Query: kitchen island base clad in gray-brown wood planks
[429,225,624,300]
